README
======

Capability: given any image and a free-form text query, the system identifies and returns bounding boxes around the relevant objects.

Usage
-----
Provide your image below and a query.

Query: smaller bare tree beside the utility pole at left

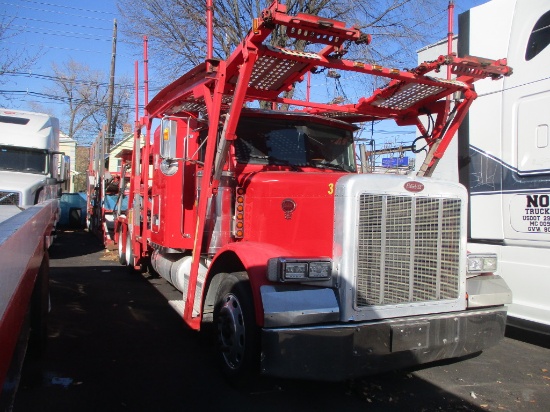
[46,60,131,143]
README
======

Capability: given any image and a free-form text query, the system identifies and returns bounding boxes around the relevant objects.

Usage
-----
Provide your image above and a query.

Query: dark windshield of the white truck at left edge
[0,146,48,174]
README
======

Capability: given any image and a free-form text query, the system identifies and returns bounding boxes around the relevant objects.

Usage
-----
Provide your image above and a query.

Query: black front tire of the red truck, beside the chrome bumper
[214,272,260,386]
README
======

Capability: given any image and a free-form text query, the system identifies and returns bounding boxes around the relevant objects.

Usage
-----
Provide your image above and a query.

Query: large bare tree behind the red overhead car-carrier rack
[117,0,446,84]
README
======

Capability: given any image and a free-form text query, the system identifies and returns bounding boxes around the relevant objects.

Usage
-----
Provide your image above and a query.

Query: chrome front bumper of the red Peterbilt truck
[261,306,506,381]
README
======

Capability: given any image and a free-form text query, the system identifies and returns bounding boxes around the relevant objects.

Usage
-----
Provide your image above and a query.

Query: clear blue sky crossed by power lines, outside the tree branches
[0,0,488,145]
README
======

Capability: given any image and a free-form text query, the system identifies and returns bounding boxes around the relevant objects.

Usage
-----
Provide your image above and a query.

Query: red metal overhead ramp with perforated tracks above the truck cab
[148,3,511,137]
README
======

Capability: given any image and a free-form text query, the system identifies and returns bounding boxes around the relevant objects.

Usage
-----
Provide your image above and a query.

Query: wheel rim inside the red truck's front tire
[218,294,245,369]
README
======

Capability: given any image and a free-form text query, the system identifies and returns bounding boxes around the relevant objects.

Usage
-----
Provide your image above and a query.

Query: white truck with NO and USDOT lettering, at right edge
[419,0,550,334]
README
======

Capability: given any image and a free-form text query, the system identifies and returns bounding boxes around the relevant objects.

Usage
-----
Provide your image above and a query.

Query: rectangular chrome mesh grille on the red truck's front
[356,194,461,307]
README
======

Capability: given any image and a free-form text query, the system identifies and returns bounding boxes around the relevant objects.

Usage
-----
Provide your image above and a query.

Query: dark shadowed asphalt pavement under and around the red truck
[13,231,550,412]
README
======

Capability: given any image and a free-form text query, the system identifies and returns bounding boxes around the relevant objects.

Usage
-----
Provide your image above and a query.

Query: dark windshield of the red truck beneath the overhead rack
[235,118,356,172]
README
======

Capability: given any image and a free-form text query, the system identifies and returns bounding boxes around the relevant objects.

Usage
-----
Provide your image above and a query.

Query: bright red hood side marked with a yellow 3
[241,171,346,256]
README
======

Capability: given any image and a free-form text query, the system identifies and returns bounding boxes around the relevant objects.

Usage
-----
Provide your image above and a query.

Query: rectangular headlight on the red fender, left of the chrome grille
[267,257,332,282]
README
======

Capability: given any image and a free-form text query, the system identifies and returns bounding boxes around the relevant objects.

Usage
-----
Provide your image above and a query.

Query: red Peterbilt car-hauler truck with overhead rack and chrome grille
[115,2,511,380]
